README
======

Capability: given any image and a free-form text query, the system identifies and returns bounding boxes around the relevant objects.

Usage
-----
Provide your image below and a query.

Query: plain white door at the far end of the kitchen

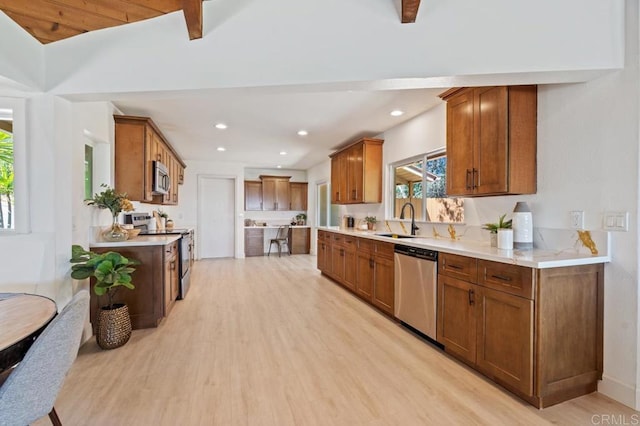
[196,176,236,259]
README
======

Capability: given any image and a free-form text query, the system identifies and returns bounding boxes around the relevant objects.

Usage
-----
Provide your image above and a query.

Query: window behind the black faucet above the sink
[392,150,464,223]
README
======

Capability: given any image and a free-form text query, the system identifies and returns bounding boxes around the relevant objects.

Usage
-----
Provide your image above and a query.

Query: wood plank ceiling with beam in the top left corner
[0,0,195,44]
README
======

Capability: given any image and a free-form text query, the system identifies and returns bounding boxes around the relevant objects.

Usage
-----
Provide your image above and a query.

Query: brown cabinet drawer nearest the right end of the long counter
[478,260,534,300]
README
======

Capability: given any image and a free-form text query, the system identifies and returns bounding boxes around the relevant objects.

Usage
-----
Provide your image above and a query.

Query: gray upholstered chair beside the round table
[0,290,89,426]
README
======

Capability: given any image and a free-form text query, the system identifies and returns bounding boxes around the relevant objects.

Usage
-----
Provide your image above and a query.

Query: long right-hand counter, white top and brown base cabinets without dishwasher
[318,228,610,408]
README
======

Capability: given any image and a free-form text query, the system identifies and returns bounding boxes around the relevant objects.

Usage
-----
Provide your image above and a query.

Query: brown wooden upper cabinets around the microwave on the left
[113,115,186,205]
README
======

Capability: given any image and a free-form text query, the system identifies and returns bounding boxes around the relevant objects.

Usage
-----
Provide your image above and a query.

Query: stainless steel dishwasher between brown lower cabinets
[394,245,438,340]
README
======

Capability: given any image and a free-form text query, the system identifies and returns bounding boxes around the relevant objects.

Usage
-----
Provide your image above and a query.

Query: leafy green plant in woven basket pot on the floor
[70,245,140,349]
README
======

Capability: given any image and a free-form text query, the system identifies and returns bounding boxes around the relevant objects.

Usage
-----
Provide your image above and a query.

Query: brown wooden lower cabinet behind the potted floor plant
[90,241,180,334]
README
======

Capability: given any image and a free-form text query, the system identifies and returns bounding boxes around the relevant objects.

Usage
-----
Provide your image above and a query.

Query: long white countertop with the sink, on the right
[318,227,611,269]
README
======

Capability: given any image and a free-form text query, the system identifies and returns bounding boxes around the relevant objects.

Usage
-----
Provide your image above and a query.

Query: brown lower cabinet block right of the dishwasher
[437,253,604,408]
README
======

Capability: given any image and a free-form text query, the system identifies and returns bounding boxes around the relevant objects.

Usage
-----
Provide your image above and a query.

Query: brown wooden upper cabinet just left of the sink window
[331,138,384,204]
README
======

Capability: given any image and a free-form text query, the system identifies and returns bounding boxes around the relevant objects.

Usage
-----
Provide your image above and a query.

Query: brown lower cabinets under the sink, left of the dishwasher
[318,230,395,315]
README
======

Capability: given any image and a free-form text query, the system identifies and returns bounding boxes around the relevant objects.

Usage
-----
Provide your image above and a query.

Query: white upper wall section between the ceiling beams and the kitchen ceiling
[45,0,624,94]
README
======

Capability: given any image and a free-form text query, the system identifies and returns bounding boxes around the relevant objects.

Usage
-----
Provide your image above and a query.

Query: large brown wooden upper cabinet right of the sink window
[440,86,537,196]
